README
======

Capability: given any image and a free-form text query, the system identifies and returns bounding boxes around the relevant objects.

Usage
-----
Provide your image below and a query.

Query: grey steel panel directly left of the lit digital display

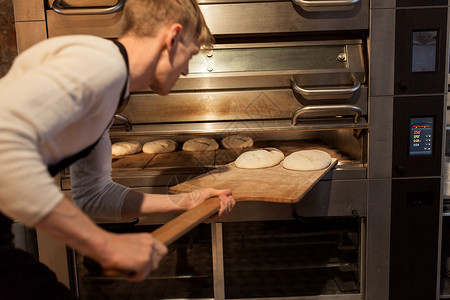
[368,96,393,179]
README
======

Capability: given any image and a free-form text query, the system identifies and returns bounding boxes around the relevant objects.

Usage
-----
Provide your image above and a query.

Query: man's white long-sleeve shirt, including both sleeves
[0,35,132,226]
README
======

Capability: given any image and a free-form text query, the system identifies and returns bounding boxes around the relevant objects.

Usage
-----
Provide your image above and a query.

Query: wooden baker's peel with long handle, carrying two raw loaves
[104,158,337,276]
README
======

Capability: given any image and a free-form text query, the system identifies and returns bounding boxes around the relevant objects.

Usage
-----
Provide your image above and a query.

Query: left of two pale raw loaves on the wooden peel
[234,148,284,169]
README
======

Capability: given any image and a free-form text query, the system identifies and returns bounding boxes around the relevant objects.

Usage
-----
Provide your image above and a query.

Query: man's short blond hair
[122,0,214,48]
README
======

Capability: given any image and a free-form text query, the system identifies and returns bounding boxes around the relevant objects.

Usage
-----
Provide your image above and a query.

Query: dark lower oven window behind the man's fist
[76,224,214,300]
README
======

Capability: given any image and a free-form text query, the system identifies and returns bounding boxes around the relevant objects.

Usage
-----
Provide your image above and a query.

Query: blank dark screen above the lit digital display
[411,30,437,72]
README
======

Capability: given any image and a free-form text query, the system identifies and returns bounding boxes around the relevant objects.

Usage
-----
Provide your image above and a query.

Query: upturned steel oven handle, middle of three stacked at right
[291,76,361,100]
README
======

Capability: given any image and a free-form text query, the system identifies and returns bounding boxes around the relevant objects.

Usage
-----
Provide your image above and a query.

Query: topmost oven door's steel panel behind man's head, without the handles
[47,0,369,38]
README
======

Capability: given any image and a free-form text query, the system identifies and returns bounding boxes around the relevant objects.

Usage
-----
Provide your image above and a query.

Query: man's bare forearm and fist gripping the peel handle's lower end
[36,198,167,281]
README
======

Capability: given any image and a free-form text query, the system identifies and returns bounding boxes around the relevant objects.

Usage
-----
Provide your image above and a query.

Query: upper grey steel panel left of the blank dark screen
[369,9,395,96]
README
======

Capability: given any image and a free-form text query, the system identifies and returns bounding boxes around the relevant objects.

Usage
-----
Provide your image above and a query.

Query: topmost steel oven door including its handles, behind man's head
[46,0,369,38]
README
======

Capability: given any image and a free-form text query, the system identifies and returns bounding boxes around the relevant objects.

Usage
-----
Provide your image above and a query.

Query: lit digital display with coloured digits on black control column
[409,117,434,156]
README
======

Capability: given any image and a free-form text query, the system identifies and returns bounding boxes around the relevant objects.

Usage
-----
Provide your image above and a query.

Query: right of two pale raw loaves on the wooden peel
[283,150,331,171]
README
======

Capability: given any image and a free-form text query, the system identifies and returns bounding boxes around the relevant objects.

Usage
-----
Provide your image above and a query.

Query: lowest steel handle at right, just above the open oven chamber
[291,105,362,126]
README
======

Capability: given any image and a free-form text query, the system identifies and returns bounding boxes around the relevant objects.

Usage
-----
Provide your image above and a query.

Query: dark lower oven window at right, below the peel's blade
[223,220,361,299]
